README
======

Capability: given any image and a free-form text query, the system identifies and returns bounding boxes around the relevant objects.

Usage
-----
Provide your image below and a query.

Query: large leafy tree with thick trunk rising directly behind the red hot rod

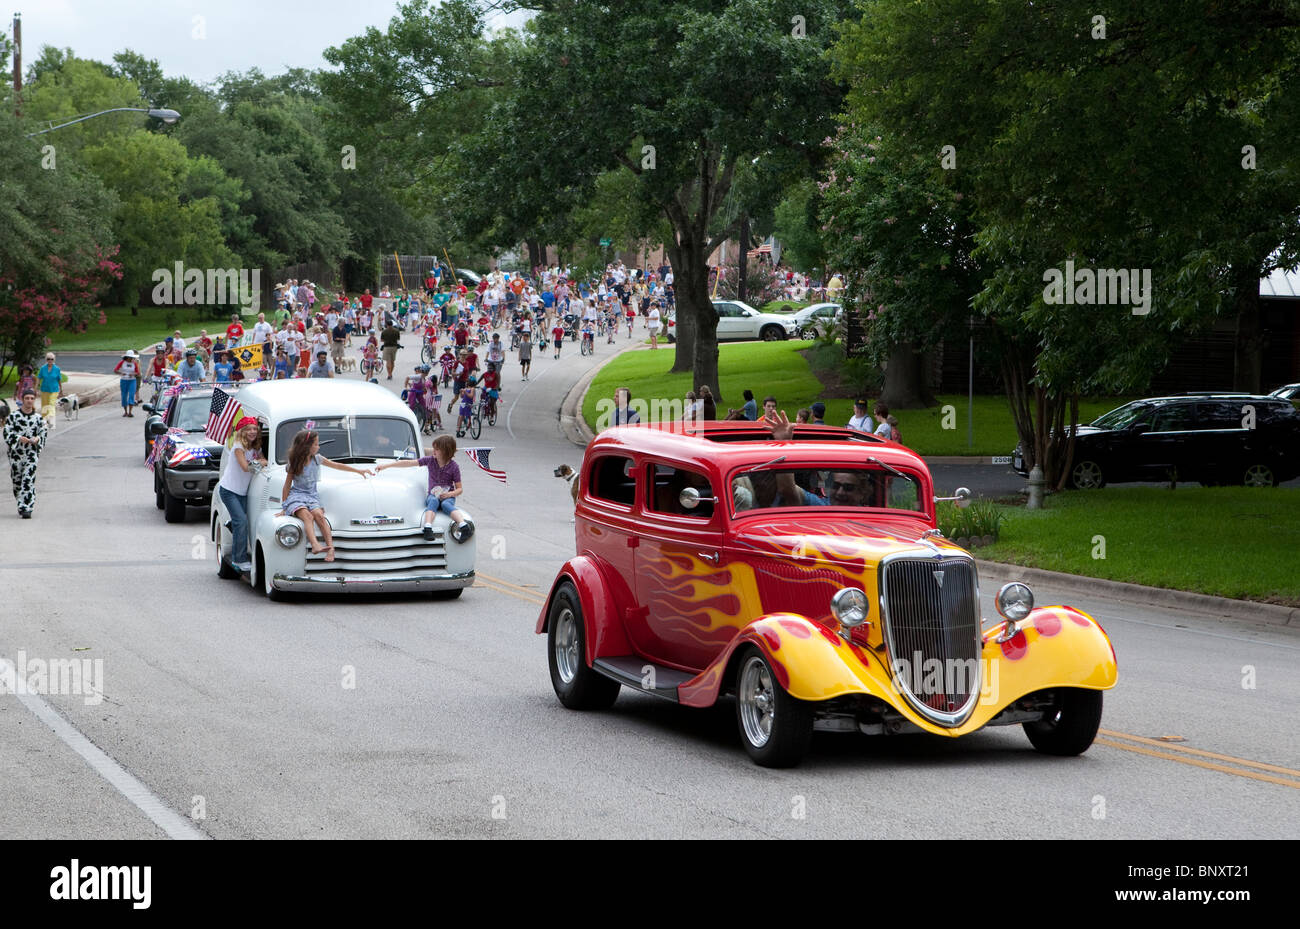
[471,0,842,396]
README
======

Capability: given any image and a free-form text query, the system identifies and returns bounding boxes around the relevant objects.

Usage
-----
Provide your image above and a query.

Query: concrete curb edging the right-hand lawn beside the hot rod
[975,559,1300,631]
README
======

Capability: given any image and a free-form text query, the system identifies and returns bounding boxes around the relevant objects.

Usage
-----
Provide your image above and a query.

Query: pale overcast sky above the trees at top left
[13,0,524,83]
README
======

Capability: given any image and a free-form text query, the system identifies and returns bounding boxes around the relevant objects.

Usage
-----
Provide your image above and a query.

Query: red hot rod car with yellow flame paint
[537,417,1117,767]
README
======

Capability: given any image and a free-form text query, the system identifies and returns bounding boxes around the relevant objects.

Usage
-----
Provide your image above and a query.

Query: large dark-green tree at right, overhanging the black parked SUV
[836,0,1300,485]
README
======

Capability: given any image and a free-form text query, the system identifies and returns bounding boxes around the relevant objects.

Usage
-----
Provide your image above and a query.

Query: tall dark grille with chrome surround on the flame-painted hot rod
[880,557,982,726]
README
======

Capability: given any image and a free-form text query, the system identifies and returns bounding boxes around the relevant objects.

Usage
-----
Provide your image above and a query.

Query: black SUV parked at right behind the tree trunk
[1011,394,1300,490]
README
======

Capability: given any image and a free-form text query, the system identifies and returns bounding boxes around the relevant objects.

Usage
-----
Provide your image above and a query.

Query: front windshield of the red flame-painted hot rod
[732,466,926,513]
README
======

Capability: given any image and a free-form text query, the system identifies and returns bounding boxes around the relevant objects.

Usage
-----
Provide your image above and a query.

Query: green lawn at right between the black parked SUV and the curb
[976,486,1300,605]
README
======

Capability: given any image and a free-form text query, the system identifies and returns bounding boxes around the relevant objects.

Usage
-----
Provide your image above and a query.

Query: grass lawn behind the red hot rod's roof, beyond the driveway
[582,340,1126,455]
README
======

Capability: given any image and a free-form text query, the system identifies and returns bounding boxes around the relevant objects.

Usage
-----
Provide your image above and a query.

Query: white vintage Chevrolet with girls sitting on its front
[209,378,475,600]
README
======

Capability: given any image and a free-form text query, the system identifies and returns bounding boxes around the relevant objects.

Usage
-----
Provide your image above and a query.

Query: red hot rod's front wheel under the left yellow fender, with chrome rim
[736,647,813,768]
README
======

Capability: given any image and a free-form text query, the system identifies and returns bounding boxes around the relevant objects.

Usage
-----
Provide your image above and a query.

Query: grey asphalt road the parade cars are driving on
[0,331,1300,838]
